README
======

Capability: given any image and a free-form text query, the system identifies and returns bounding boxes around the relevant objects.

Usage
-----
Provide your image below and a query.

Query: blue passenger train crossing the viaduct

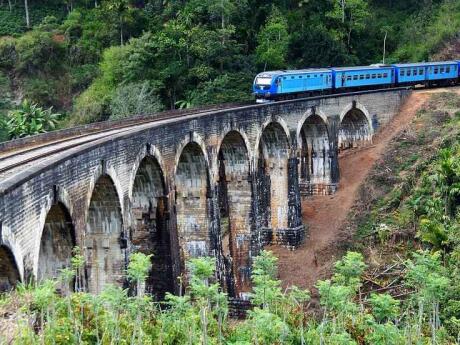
[253,60,460,103]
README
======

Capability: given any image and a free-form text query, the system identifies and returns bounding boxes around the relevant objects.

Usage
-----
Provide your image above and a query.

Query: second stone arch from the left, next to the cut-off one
[37,202,75,290]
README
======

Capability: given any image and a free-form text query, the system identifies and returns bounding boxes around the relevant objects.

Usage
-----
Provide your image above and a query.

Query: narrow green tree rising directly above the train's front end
[256,7,290,71]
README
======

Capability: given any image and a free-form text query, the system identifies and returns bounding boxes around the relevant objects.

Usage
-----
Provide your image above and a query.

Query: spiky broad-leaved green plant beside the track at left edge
[6,100,60,139]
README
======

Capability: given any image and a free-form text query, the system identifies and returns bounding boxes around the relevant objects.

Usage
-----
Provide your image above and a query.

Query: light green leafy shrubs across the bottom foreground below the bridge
[5,243,457,345]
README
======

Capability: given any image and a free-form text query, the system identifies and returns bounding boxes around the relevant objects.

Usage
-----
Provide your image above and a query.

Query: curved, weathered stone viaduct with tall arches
[0,89,409,298]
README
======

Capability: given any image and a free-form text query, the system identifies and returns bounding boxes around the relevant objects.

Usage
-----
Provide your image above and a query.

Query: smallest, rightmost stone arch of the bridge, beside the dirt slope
[338,102,373,150]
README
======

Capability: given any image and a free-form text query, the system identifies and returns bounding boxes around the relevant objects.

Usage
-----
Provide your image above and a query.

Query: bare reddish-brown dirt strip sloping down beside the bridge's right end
[267,88,460,289]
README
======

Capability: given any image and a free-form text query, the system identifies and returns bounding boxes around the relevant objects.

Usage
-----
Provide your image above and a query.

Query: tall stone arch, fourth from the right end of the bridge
[217,131,252,298]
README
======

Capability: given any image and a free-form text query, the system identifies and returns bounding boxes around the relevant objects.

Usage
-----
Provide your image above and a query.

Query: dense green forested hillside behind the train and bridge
[0,0,460,140]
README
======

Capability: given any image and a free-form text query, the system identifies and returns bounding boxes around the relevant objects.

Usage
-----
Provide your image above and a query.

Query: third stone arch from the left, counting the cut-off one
[84,174,126,293]
